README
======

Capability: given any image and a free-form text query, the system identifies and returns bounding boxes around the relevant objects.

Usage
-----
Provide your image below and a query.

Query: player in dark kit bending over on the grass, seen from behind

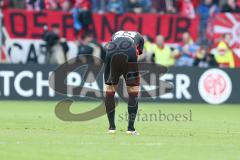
[104,31,144,135]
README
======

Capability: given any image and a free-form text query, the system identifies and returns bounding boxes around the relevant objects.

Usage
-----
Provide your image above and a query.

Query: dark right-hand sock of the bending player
[128,95,138,131]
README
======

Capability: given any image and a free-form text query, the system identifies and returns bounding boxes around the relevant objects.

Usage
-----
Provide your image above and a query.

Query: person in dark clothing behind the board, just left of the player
[78,33,101,63]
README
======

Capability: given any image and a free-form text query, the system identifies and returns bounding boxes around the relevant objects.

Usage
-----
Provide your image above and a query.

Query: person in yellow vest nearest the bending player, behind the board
[153,35,175,67]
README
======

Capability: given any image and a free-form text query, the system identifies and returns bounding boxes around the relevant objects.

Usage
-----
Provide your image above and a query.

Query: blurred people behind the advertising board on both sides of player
[44,28,235,68]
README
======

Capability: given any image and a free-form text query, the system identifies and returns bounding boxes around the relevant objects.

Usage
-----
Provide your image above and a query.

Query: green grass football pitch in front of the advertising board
[0,101,240,160]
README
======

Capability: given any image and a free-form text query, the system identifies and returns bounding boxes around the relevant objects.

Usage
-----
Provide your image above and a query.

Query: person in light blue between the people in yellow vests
[176,32,198,66]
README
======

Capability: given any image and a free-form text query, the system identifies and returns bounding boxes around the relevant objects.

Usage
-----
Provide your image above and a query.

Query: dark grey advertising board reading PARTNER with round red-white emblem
[0,64,240,104]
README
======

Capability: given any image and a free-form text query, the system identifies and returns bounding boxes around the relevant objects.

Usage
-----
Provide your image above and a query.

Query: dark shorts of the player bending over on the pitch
[104,37,140,86]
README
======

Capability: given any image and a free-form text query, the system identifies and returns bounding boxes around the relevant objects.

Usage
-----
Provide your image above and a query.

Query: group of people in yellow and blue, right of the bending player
[139,32,235,68]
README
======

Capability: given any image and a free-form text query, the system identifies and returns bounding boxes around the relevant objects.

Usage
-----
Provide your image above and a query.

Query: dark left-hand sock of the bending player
[105,93,116,130]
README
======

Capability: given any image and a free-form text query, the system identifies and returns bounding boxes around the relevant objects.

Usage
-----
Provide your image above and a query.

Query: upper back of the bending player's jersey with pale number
[112,31,144,55]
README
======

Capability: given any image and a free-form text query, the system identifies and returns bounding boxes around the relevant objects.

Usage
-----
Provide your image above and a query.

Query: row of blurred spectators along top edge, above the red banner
[0,0,240,13]
